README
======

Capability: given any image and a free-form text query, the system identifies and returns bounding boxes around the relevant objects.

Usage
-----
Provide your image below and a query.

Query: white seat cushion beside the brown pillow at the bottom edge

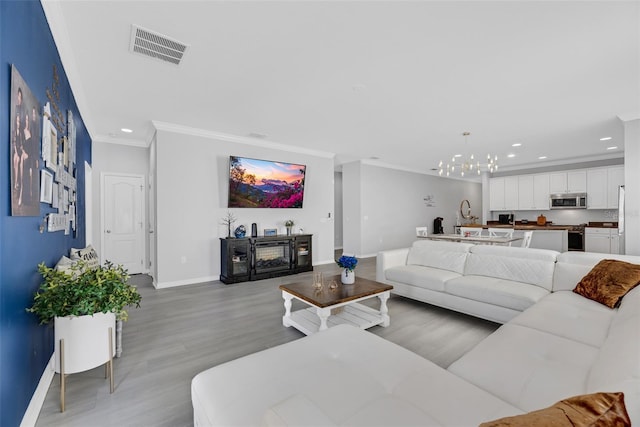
[448,323,600,411]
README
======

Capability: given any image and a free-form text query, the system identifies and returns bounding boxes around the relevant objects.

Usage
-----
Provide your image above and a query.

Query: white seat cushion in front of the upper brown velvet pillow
[511,291,616,347]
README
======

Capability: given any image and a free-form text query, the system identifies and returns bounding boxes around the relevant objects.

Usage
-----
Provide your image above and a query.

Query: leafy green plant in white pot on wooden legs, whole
[27,261,142,411]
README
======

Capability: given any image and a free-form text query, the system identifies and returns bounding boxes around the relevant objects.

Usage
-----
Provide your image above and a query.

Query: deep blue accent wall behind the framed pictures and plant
[0,0,91,427]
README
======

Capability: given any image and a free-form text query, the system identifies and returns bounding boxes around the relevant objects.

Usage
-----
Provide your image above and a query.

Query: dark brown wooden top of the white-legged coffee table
[280,274,393,308]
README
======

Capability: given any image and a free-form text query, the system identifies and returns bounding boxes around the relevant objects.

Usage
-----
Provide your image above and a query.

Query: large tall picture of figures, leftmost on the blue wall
[9,65,41,216]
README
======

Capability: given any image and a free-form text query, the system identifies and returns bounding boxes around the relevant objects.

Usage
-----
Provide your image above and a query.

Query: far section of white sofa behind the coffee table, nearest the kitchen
[376,240,559,323]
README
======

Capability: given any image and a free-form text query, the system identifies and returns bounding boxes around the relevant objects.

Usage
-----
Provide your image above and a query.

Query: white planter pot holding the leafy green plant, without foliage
[54,313,116,374]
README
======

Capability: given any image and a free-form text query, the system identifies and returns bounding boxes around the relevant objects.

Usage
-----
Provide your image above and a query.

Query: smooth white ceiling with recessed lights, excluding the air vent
[43,0,640,177]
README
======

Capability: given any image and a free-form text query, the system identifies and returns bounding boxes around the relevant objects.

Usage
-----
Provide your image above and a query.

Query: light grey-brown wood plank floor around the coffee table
[36,258,499,427]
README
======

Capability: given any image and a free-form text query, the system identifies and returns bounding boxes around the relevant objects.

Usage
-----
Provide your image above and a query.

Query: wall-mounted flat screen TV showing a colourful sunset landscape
[229,156,307,208]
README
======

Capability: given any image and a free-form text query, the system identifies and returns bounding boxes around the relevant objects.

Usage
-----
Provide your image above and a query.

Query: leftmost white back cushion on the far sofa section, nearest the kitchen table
[407,240,473,274]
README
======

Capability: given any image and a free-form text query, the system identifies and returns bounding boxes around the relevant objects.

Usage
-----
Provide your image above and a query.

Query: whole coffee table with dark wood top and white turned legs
[280,275,393,335]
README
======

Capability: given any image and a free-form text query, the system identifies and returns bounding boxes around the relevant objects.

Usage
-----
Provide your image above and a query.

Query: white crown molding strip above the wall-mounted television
[151,120,335,159]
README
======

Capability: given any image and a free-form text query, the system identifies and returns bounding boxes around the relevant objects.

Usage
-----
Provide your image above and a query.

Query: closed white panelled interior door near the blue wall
[101,173,146,274]
